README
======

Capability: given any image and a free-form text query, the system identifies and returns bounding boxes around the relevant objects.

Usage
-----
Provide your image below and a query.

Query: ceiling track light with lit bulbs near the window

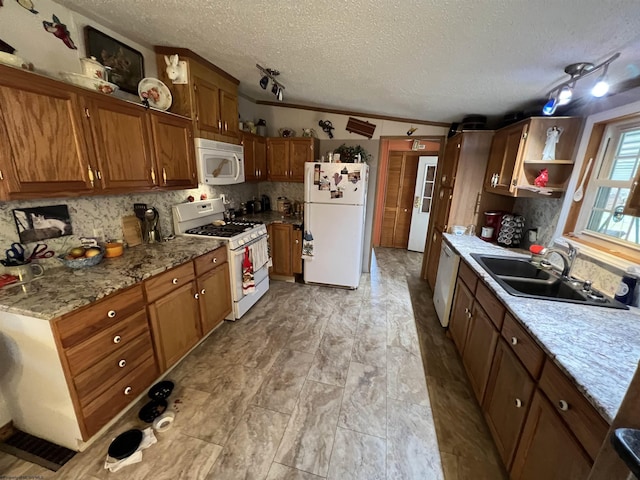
[542,53,620,115]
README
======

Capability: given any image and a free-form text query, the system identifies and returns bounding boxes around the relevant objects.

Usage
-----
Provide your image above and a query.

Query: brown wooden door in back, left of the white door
[380,152,420,249]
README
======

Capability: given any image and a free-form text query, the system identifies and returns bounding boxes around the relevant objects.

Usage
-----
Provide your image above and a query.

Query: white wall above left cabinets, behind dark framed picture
[0,0,158,99]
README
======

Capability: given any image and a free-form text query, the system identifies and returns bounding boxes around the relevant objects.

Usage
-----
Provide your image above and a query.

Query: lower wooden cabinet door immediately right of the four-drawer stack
[149,281,202,372]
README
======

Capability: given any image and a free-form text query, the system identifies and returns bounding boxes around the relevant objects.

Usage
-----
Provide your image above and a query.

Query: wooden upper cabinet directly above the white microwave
[155,46,240,144]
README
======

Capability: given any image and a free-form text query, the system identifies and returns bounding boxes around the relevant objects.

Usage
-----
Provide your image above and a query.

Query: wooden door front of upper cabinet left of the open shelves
[485,122,529,195]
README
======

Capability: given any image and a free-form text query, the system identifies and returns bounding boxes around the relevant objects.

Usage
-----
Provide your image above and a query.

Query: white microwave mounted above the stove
[195,138,244,185]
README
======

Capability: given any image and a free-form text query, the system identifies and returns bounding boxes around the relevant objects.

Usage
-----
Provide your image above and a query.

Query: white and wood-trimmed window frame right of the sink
[555,97,640,268]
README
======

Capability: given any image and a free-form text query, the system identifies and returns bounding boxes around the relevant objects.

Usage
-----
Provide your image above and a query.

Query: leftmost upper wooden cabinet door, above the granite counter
[0,74,94,199]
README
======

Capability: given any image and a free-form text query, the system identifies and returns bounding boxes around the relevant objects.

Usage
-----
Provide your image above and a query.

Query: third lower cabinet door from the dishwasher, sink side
[482,340,535,469]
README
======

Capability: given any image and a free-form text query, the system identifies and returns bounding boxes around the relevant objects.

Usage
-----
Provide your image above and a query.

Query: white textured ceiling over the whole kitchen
[56,0,640,122]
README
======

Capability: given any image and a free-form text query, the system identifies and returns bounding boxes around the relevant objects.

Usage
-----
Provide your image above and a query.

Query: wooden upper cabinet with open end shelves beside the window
[484,117,581,197]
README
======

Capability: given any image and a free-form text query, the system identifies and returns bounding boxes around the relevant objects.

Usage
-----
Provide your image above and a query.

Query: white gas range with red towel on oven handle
[172,198,269,320]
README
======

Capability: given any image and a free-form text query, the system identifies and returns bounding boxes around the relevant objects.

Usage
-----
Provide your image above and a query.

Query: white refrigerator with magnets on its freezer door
[302,162,369,289]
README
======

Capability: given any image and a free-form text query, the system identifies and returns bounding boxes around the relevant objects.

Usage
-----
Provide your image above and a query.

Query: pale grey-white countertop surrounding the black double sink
[444,234,640,423]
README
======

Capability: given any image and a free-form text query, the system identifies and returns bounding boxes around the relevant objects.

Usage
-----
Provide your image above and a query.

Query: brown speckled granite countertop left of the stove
[0,237,225,320]
